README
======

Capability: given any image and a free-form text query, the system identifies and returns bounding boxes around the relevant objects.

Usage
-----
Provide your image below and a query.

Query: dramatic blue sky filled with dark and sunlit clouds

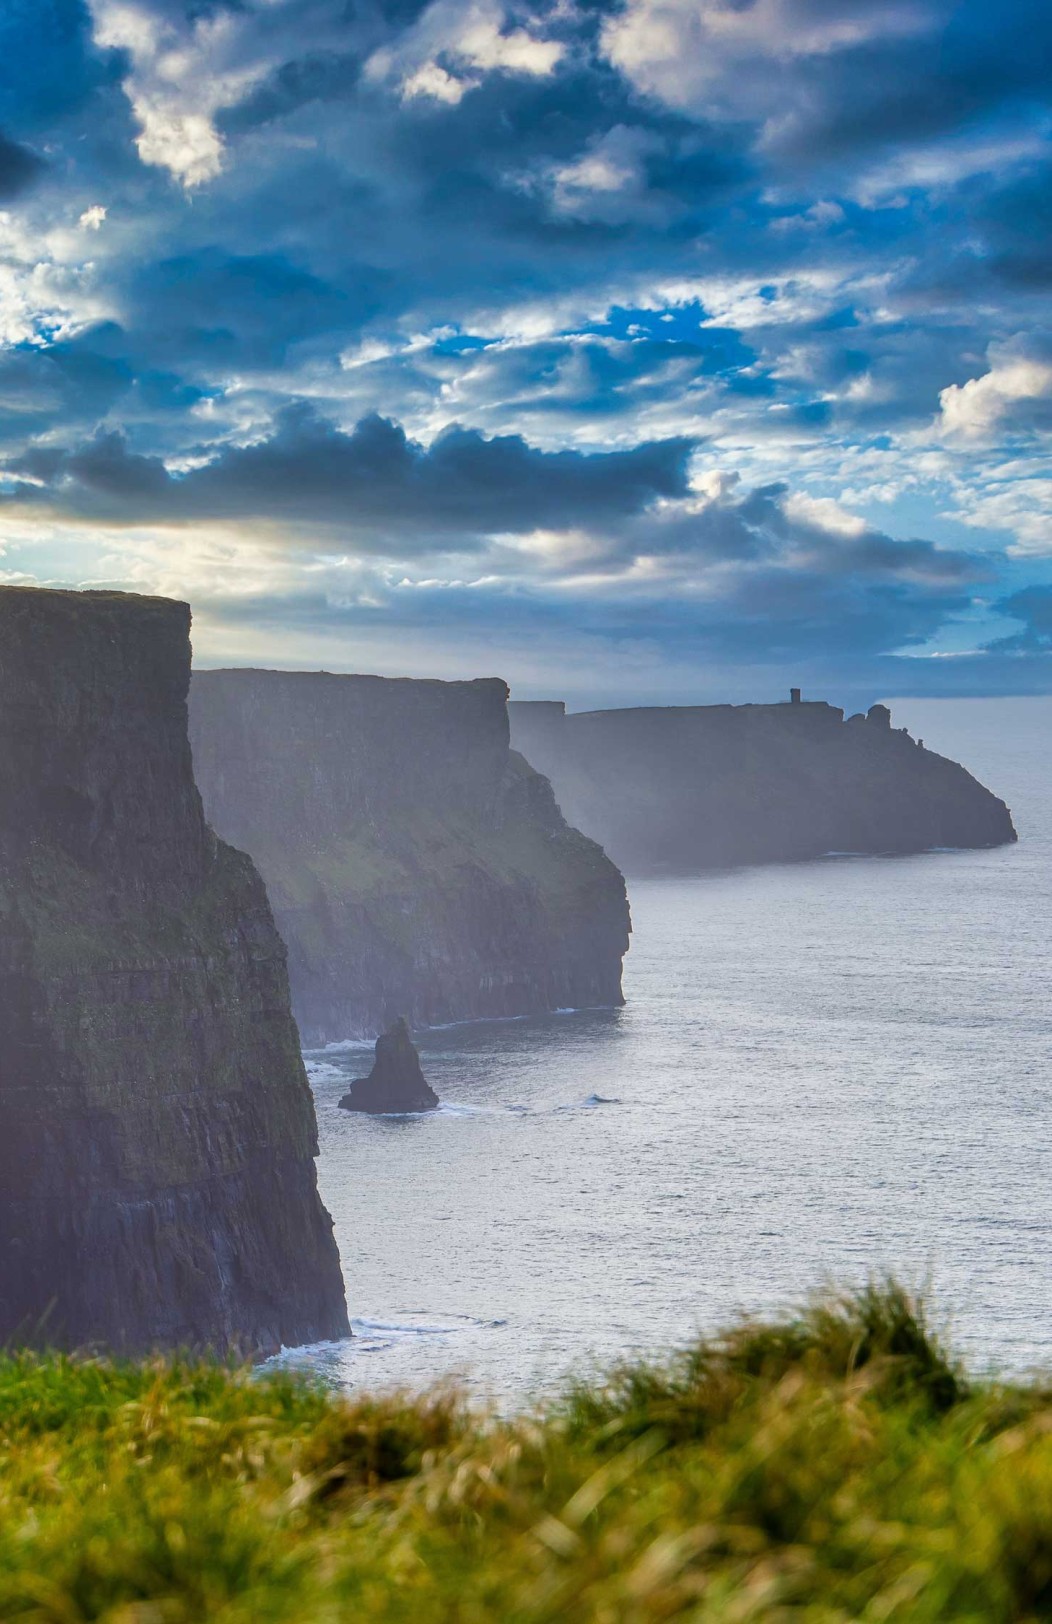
[0,0,1052,708]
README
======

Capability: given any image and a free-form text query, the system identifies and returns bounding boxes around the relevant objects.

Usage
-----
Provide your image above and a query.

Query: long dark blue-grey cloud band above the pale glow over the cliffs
[10,406,692,539]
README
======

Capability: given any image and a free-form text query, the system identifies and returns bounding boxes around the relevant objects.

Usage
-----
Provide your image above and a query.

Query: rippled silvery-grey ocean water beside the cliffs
[277,700,1052,1403]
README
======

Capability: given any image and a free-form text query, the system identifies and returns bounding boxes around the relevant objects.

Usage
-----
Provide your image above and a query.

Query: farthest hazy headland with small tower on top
[508,703,1016,874]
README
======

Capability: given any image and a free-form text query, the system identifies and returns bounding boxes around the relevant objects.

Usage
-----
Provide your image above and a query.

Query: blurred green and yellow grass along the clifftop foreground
[0,1286,1052,1624]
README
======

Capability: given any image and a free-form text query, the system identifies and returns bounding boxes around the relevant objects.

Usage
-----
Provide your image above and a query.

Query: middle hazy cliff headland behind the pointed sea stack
[190,671,628,1043]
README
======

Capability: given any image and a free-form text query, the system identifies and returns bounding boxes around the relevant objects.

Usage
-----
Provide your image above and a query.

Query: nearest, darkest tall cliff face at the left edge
[0,588,347,1353]
